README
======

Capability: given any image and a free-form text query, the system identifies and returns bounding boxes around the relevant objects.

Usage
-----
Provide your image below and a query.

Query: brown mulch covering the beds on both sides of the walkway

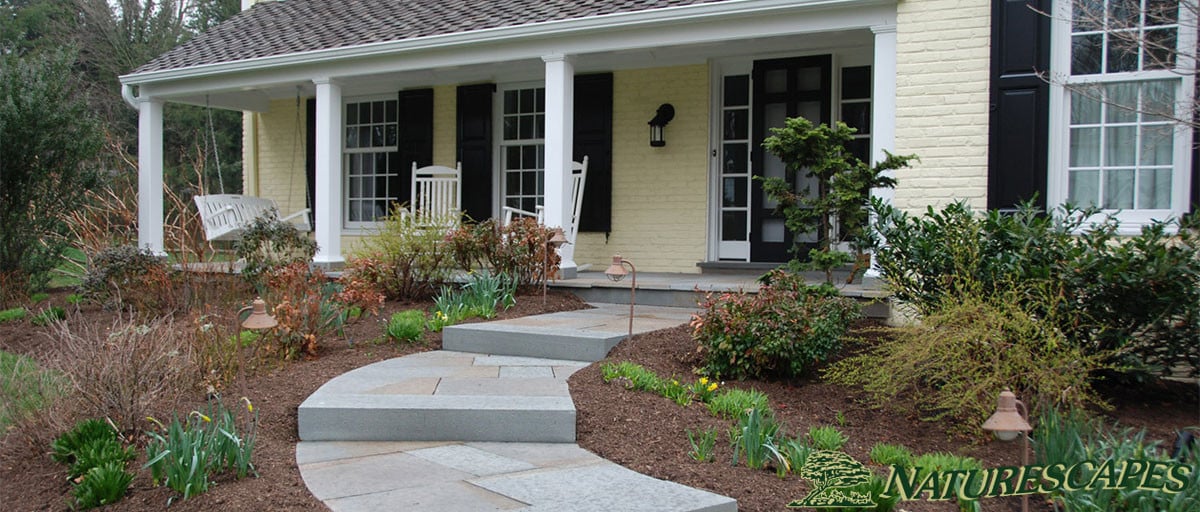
[0,291,1200,512]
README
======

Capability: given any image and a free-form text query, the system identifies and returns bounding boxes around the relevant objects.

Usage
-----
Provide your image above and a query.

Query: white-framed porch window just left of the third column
[498,84,546,212]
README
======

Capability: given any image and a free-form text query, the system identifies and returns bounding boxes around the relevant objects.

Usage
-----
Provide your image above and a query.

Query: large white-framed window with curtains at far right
[1048,0,1196,233]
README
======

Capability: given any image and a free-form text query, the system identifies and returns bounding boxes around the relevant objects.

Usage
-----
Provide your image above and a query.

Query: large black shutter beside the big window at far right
[988,0,1050,209]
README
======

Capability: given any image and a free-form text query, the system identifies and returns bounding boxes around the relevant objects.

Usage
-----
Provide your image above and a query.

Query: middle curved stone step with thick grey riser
[298,350,584,442]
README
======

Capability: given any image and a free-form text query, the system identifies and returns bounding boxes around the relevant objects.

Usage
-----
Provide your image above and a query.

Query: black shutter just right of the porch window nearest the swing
[388,89,434,207]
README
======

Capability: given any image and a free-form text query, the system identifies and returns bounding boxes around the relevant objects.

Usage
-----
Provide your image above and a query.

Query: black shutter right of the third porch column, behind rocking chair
[571,73,612,233]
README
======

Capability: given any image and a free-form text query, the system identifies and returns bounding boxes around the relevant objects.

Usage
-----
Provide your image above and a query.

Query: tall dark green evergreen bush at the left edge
[0,52,101,300]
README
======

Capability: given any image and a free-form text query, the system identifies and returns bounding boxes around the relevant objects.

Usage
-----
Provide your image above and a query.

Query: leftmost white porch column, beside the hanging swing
[138,98,167,257]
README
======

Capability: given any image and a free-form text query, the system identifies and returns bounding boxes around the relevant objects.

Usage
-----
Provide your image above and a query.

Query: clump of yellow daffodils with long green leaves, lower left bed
[145,398,258,500]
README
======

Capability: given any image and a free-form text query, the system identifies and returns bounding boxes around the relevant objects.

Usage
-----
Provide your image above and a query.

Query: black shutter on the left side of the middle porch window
[456,84,496,221]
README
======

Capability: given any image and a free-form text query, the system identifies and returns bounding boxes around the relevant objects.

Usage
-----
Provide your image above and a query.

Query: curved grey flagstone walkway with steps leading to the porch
[296,306,737,512]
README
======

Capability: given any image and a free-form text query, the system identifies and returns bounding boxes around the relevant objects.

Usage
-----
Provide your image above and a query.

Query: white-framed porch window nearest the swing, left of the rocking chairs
[342,97,406,229]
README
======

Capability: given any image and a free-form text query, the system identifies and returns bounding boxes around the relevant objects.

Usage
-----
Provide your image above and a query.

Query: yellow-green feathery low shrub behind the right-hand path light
[824,296,1102,434]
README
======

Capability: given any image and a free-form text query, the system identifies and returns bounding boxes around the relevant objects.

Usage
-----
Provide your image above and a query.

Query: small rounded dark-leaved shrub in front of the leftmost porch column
[79,246,178,312]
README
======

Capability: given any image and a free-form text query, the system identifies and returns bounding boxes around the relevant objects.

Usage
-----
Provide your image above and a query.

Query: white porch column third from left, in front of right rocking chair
[541,55,576,278]
